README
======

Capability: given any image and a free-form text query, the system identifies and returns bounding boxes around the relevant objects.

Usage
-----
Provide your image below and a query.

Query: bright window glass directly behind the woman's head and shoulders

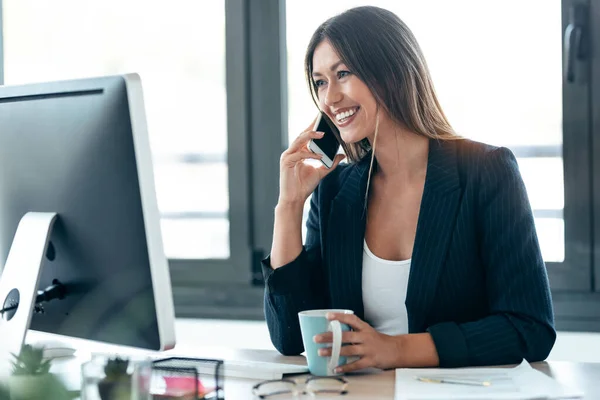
[287,0,565,262]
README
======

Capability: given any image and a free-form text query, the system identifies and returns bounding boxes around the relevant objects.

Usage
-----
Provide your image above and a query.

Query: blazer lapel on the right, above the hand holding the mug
[406,140,462,333]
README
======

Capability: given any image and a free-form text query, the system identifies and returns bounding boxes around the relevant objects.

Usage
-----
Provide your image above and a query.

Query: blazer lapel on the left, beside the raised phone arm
[324,155,371,319]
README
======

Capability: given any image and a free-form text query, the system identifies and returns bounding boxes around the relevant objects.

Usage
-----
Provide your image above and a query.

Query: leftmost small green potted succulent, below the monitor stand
[8,345,71,400]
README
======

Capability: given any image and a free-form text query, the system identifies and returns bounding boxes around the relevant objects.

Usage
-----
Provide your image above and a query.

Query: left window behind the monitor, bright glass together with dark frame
[0,0,287,319]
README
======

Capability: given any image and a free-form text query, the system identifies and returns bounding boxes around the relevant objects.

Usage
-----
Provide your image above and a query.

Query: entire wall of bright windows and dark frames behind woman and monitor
[0,0,600,360]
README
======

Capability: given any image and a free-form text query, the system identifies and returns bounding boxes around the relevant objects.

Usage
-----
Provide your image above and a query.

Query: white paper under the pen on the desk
[395,360,583,400]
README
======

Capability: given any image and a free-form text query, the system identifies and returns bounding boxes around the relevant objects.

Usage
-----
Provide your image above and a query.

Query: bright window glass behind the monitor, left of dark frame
[3,0,230,259]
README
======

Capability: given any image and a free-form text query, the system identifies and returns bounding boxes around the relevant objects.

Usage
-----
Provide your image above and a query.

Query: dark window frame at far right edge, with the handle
[547,0,600,332]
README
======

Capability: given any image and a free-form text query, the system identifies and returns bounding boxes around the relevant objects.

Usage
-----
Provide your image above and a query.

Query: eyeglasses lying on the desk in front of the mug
[252,376,348,399]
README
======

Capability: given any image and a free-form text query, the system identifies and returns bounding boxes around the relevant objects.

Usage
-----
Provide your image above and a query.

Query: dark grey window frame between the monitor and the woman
[149,0,287,319]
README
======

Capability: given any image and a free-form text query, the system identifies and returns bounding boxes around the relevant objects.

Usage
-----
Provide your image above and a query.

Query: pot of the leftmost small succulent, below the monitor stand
[8,374,70,400]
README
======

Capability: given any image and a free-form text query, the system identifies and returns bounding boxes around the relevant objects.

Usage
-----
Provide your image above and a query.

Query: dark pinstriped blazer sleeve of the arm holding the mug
[428,148,556,367]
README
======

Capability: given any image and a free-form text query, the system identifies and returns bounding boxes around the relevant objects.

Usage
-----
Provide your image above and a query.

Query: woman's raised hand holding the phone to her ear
[279,120,346,206]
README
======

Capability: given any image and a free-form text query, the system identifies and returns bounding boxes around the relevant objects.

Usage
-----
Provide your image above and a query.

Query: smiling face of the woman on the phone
[312,40,377,143]
